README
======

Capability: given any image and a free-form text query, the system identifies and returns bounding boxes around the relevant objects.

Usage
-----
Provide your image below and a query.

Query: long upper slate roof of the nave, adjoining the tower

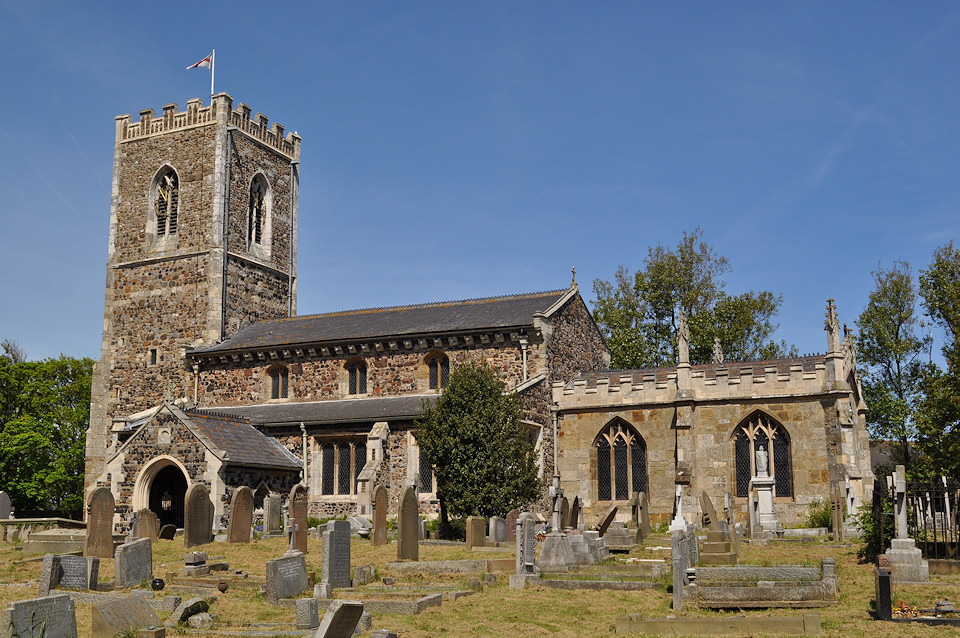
[189,288,570,354]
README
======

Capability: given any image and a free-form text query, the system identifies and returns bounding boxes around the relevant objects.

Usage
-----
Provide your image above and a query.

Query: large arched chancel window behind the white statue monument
[733,412,793,497]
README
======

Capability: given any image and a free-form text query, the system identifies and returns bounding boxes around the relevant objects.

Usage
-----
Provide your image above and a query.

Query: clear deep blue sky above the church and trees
[0,1,960,358]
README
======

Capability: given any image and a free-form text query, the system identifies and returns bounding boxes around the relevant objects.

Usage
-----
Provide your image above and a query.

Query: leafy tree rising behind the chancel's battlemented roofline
[593,228,796,368]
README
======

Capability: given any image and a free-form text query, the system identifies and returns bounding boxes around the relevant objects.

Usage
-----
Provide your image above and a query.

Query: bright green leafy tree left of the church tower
[0,350,93,517]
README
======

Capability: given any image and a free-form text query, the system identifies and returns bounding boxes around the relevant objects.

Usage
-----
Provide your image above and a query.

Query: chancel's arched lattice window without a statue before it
[593,419,647,501]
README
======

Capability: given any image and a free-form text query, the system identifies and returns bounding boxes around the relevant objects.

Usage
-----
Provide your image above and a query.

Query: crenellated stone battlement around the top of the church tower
[116,93,301,160]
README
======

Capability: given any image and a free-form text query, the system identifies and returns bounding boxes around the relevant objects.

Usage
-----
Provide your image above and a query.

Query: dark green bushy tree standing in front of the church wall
[416,363,543,534]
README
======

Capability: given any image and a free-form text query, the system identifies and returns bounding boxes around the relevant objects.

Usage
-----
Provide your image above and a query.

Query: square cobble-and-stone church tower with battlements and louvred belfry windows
[85,93,300,490]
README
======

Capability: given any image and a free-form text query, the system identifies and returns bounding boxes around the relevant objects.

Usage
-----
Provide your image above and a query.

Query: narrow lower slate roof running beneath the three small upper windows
[199,394,437,425]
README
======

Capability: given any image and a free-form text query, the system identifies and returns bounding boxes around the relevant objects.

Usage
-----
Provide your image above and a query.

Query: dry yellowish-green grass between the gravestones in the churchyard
[0,537,960,638]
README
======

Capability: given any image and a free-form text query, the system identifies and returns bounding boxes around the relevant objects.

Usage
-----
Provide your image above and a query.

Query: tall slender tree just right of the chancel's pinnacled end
[856,261,925,466]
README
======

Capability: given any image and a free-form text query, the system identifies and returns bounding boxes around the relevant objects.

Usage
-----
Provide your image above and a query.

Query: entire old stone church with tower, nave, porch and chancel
[85,93,870,529]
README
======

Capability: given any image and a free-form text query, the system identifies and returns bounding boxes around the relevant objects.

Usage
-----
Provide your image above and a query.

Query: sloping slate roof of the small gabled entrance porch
[184,410,302,469]
